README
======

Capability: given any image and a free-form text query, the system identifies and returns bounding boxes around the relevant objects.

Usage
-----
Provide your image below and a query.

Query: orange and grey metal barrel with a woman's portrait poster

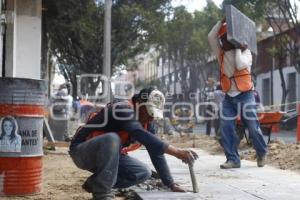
[0,78,47,196]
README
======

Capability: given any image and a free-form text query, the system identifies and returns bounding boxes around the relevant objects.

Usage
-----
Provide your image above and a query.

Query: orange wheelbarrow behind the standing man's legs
[236,111,285,144]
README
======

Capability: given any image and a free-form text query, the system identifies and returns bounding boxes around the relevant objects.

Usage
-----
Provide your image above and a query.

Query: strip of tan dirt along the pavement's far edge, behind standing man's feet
[164,135,300,173]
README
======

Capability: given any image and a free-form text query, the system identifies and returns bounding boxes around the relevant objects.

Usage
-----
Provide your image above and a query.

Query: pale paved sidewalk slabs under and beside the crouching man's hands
[130,150,300,200]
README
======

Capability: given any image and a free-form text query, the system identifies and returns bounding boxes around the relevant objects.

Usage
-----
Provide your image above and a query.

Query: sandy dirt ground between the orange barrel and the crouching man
[0,147,128,200]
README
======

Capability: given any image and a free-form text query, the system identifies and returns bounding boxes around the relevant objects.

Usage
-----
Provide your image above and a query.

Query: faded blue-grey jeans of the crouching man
[70,133,151,197]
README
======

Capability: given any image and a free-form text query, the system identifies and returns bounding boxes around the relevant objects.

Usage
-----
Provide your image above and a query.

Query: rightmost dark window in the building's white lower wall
[287,72,297,110]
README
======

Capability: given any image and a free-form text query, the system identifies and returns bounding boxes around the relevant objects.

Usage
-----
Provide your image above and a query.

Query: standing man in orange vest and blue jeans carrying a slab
[208,18,267,169]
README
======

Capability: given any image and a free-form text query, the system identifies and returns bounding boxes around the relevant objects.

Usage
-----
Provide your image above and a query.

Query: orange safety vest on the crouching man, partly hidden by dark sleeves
[82,101,148,154]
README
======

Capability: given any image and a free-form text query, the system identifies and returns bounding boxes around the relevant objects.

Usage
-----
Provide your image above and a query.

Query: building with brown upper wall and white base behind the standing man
[253,29,300,110]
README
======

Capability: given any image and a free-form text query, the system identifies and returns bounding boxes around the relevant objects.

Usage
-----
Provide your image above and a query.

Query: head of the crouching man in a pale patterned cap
[132,87,165,123]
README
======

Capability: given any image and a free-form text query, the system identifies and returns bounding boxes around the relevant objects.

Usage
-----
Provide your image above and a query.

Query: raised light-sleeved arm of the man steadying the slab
[208,21,222,62]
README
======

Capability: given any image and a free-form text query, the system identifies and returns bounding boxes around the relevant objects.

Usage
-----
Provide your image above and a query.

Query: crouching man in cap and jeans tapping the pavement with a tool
[70,88,198,200]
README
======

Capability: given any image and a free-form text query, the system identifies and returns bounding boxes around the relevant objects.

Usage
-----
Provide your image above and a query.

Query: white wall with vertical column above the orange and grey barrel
[0,0,42,79]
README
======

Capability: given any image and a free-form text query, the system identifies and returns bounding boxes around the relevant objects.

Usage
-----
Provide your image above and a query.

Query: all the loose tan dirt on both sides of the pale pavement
[0,132,300,200]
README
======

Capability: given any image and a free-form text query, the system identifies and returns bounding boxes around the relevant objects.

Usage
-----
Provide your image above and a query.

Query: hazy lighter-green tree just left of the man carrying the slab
[150,0,221,96]
